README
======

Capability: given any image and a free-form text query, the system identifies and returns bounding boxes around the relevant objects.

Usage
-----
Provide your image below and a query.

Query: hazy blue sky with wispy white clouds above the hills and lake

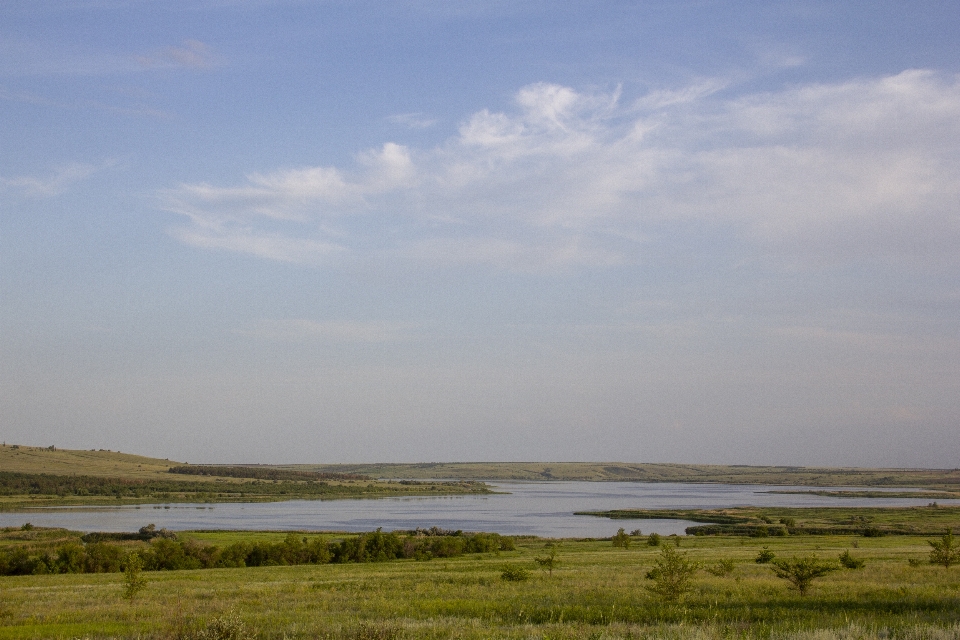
[0,0,960,468]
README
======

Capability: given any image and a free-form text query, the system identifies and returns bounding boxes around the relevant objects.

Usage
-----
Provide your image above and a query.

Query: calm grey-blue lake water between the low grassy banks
[0,482,948,537]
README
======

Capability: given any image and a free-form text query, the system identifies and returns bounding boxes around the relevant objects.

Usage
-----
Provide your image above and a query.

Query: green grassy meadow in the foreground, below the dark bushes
[0,523,960,640]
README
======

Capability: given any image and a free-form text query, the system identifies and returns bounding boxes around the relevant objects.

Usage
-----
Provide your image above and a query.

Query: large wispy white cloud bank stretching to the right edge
[164,70,960,269]
